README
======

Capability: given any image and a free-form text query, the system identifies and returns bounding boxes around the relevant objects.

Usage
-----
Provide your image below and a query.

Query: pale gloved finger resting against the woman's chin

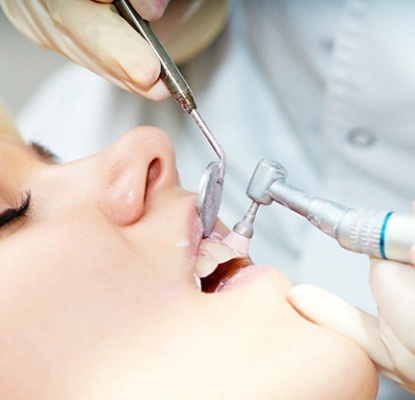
[287,285,393,377]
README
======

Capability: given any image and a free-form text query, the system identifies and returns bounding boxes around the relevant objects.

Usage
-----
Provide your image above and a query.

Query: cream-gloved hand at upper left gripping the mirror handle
[0,0,169,100]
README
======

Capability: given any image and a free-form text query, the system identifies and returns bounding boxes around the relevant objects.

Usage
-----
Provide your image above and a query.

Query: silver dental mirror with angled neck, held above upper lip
[113,0,226,237]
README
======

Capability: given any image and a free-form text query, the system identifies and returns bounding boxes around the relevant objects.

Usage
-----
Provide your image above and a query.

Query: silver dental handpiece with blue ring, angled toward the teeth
[229,160,415,264]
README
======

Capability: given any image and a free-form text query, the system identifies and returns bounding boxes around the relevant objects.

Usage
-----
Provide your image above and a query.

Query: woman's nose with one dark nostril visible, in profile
[97,127,179,226]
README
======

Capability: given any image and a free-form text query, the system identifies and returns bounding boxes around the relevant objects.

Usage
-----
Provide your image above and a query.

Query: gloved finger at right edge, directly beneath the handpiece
[370,259,415,355]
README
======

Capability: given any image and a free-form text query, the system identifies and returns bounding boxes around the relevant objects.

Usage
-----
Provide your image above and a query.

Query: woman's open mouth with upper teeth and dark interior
[195,233,252,293]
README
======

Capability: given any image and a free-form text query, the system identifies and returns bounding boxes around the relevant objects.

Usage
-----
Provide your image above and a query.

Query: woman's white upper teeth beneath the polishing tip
[195,239,244,278]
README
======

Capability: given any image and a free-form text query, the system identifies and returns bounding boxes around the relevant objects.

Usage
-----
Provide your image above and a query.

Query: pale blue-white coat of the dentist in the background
[20,0,415,399]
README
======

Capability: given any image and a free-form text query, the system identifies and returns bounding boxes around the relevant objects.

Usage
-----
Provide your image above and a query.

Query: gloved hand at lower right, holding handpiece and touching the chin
[288,256,415,393]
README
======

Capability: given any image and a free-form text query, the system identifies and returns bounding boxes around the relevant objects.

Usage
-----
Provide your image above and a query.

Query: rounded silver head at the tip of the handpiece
[246,160,287,205]
